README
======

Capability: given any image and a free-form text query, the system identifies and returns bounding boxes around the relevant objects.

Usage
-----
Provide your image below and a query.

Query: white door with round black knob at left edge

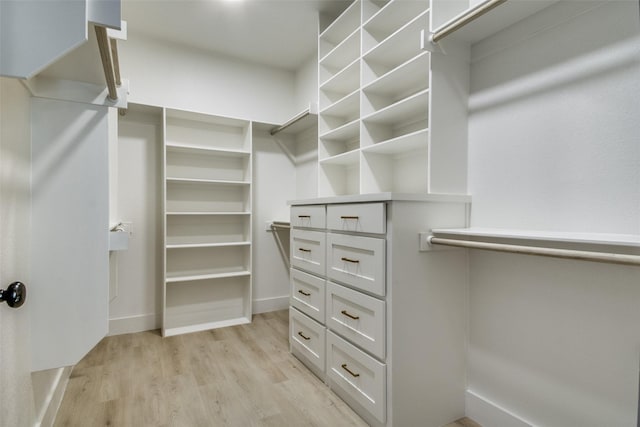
[0,78,34,427]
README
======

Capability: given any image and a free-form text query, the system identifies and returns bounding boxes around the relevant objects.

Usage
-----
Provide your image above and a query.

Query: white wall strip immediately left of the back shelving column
[109,107,163,334]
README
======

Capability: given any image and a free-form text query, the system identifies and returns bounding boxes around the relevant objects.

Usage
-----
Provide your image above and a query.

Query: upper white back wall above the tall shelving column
[118,32,297,123]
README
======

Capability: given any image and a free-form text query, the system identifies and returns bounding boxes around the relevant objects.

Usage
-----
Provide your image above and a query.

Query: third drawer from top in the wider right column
[326,282,386,359]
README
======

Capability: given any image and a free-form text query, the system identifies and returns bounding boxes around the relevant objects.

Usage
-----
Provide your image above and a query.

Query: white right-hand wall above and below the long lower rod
[467,1,640,426]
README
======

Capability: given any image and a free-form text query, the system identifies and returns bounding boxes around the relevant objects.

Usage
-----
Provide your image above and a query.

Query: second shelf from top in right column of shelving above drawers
[363,7,429,68]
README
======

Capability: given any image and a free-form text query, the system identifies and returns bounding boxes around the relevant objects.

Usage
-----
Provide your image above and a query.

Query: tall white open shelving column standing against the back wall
[162,109,252,336]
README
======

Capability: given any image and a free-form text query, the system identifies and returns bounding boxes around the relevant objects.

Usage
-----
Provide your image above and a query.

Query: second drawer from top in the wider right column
[327,233,386,296]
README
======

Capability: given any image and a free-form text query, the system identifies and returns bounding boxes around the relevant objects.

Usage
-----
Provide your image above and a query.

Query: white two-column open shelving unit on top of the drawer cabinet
[318,0,468,197]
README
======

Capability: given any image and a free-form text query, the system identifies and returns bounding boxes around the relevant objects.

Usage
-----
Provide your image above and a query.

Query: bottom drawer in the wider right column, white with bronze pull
[327,331,386,423]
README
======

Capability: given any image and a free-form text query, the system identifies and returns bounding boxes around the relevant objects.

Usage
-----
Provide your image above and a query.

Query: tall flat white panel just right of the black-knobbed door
[29,98,109,371]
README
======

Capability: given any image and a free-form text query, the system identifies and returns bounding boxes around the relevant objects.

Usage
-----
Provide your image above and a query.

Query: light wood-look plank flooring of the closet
[55,311,478,427]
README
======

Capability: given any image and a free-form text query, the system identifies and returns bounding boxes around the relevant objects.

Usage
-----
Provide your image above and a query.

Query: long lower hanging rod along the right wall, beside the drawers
[427,236,640,265]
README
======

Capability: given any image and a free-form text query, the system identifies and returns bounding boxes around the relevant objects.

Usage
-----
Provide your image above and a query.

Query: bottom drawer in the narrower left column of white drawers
[289,308,326,376]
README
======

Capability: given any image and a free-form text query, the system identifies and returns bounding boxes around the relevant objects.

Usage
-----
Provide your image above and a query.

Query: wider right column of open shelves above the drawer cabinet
[360,0,430,193]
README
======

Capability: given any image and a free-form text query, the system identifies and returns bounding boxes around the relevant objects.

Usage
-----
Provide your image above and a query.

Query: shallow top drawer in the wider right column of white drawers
[327,203,387,234]
